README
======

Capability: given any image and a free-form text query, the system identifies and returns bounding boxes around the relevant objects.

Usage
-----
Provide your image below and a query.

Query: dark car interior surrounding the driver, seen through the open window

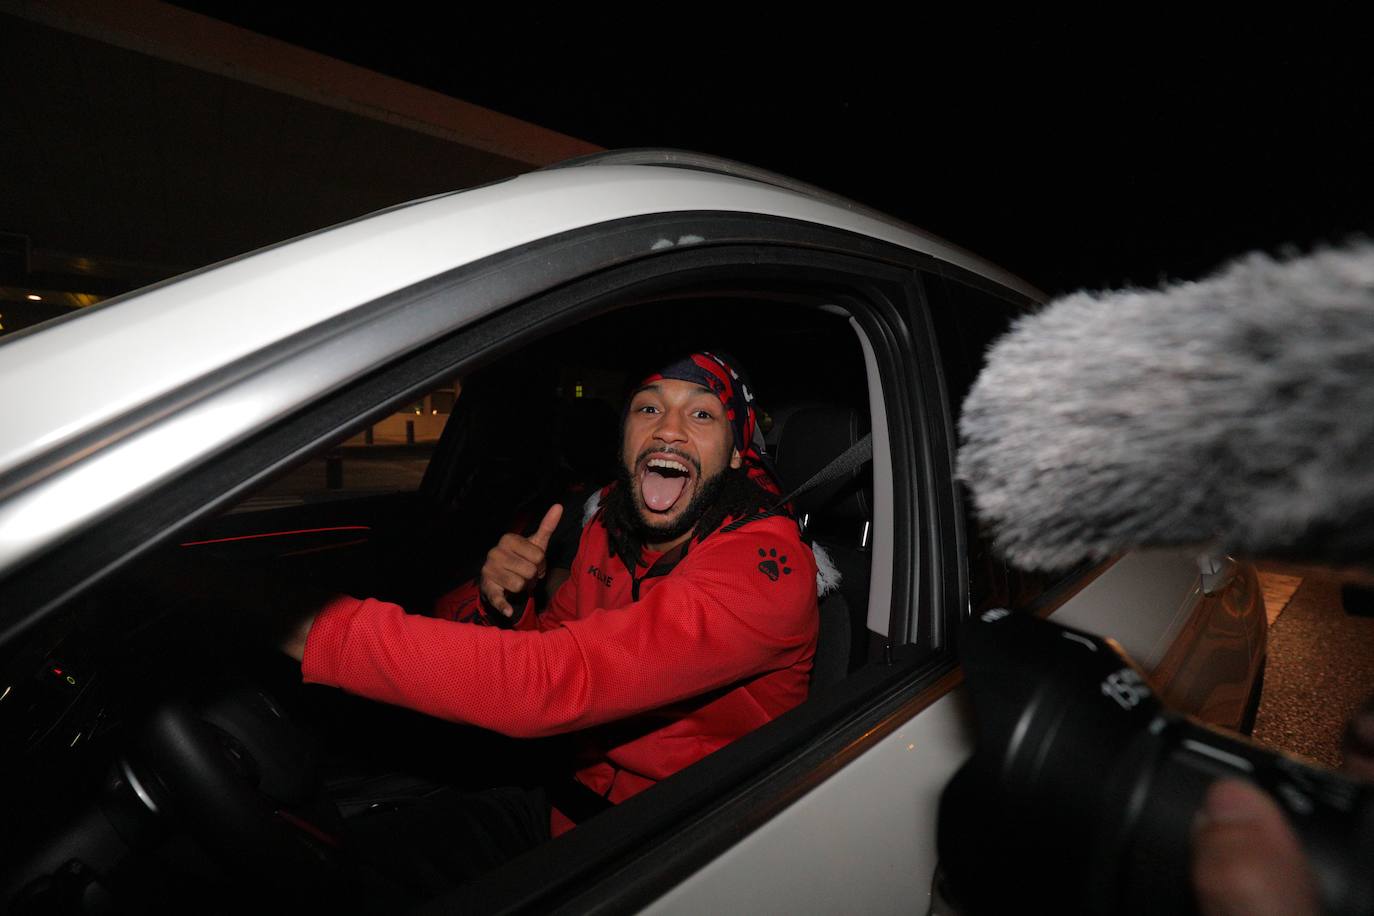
[0,288,883,912]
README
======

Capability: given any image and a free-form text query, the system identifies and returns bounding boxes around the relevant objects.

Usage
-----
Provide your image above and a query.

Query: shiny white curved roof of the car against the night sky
[0,151,1043,571]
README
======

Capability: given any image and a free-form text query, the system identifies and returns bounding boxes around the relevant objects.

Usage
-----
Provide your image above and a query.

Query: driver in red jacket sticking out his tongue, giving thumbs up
[284,353,818,835]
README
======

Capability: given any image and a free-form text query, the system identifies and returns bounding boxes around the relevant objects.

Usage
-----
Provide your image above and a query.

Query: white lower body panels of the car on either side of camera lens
[649,552,1247,913]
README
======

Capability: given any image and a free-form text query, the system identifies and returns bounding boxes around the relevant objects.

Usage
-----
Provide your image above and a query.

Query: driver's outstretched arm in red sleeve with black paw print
[302,519,816,736]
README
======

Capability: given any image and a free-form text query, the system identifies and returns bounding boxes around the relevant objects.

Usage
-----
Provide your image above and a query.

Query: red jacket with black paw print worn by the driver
[301,508,819,832]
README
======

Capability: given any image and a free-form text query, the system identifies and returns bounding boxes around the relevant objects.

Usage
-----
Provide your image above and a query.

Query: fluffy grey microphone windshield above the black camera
[959,240,1374,569]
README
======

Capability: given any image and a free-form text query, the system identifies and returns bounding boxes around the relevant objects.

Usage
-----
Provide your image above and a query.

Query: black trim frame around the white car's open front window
[2,214,952,901]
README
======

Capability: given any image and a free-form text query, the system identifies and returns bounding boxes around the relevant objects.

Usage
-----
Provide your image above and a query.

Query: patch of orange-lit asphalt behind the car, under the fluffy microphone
[1254,567,1374,768]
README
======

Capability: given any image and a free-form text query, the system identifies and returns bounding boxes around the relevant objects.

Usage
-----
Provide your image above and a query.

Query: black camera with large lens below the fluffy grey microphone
[938,608,1374,915]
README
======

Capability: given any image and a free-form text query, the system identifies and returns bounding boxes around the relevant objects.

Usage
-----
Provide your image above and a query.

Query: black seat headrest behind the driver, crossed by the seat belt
[775,405,872,523]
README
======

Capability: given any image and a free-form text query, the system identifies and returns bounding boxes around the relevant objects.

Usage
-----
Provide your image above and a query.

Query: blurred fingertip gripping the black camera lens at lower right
[1193,779,1322,916]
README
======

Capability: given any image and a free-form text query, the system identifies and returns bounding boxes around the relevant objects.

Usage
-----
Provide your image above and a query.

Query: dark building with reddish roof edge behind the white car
[0,0,598,332]
